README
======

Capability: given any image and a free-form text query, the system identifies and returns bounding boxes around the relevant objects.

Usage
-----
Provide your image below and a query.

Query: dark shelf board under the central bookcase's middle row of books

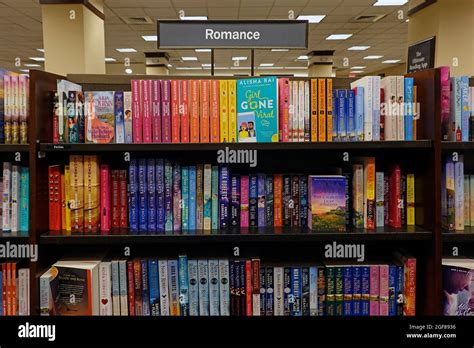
[40,227,432,245]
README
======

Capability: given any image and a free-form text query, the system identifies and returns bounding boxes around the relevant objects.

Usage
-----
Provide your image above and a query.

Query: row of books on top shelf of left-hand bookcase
[0,69,29,144]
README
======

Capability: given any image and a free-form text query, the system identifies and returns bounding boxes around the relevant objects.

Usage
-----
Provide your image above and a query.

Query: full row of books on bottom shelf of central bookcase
[40,254,416,316]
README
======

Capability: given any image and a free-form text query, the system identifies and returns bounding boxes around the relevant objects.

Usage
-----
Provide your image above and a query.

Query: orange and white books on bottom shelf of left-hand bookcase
[0,261,30,316]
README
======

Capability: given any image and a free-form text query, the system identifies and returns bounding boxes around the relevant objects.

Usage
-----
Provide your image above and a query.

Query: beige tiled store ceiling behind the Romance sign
[0,0,408,74]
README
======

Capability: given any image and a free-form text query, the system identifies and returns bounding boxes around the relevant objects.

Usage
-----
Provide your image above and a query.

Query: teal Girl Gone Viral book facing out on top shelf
[237,76,278,143]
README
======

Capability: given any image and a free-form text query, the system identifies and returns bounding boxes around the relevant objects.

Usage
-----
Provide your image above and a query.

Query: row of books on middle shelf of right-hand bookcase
[441,155,474,231]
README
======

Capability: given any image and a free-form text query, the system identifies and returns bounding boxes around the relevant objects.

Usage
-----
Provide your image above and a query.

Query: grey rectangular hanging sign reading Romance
[158,20,308,49]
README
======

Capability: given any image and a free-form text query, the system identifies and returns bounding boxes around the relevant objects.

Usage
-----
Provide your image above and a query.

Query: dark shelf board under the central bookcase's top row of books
[40,140,432,152]
